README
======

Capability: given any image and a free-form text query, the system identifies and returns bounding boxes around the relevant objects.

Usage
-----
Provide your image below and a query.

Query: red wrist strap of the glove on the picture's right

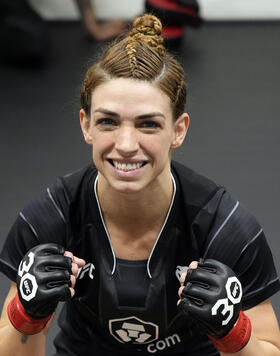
[207,310,251,354]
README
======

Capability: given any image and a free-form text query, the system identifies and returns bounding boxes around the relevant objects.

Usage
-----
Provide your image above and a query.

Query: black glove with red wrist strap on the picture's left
[8,243,72,335]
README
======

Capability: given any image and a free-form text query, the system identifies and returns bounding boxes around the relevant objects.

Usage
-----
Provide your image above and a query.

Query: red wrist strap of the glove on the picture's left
[8,294,52,335]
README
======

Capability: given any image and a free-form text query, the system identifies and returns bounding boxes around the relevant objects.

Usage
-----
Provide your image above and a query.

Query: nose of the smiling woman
[115,126,139,156]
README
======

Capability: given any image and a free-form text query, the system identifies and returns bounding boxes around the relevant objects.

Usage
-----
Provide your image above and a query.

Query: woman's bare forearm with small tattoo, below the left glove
[0,282,48,356]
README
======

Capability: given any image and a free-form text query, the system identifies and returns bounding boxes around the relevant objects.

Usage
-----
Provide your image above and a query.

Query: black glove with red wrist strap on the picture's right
[179,259,251,353]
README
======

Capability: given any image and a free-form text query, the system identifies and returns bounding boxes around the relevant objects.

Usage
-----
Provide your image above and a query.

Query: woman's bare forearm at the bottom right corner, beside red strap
[221,300,280,356]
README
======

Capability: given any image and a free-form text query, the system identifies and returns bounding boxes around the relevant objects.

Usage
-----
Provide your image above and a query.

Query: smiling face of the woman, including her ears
[80,78,189,193]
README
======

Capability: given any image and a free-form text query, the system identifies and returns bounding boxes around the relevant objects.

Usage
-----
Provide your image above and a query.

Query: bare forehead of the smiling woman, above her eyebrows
[91,78,172,116]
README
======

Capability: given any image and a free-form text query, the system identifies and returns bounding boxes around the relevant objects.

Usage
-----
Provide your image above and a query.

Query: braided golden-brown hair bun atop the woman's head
[128,14,166,55]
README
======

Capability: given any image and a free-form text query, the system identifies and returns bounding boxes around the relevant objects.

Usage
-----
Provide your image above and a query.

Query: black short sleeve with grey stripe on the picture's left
[0,179,69,281]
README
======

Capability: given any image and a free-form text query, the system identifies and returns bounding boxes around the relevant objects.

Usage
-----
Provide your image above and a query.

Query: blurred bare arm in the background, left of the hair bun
[76,0,126,41]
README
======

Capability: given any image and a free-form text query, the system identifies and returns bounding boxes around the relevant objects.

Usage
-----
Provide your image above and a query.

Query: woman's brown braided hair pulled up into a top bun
[81,14,186,120]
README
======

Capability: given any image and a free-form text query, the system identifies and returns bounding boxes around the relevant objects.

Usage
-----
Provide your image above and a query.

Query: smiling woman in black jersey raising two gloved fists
[0,15,280,356]
